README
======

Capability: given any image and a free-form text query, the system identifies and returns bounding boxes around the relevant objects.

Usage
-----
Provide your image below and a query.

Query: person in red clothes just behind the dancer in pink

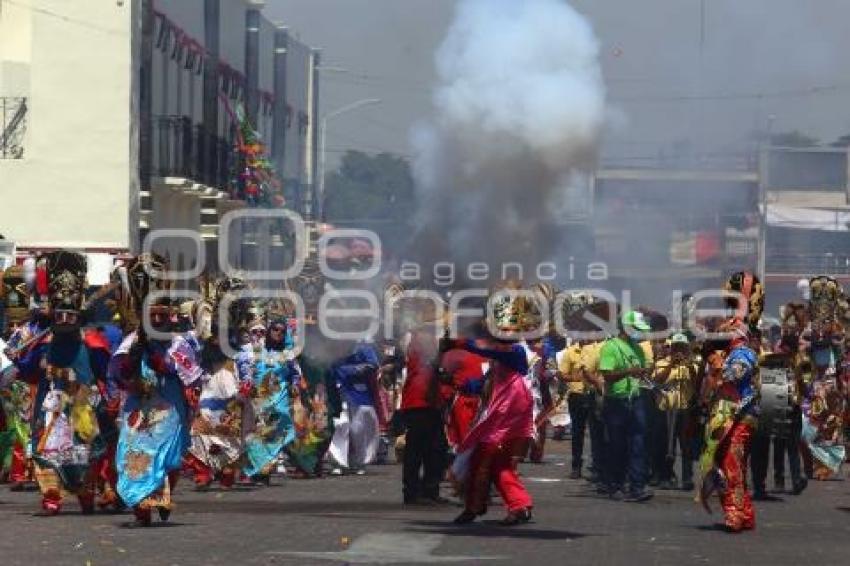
[440,347,488,454]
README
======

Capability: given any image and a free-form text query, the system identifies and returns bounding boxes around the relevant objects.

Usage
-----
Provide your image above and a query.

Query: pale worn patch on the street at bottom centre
[267,533,508,564]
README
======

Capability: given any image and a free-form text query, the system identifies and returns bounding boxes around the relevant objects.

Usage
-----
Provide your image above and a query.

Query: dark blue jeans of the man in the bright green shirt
[602,397,646,493]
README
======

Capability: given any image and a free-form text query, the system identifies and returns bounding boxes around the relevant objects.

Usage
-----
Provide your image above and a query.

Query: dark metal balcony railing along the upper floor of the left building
[153,116,237,191]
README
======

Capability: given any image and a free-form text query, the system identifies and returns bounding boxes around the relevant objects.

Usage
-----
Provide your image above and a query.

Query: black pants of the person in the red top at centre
[402,409,448,501]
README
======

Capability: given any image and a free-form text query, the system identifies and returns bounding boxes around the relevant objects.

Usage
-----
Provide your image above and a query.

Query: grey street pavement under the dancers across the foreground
[0,442,850,566]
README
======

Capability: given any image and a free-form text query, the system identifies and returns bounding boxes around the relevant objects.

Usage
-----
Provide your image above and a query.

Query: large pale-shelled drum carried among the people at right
[759,356,796,438]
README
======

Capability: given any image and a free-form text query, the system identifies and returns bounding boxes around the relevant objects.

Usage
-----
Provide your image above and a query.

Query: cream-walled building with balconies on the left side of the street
[0,0,318,276]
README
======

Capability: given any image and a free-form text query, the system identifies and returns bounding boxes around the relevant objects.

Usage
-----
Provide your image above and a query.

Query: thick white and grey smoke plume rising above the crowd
[413,0,607,278]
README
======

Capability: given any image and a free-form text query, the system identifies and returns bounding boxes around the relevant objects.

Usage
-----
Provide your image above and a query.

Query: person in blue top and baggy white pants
[329,340,380,475]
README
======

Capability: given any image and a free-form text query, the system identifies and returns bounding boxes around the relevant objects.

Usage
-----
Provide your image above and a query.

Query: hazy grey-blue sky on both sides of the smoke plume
[266,0,850,165]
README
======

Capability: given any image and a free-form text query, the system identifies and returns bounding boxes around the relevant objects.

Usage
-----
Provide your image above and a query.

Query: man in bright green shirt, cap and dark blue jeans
[599,311,653,502]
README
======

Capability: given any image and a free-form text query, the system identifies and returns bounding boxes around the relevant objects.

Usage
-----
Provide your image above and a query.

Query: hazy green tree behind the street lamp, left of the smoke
[325,151,414,224]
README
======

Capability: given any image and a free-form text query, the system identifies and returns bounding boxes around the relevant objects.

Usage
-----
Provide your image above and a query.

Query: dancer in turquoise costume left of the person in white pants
[236,304,300,485]
